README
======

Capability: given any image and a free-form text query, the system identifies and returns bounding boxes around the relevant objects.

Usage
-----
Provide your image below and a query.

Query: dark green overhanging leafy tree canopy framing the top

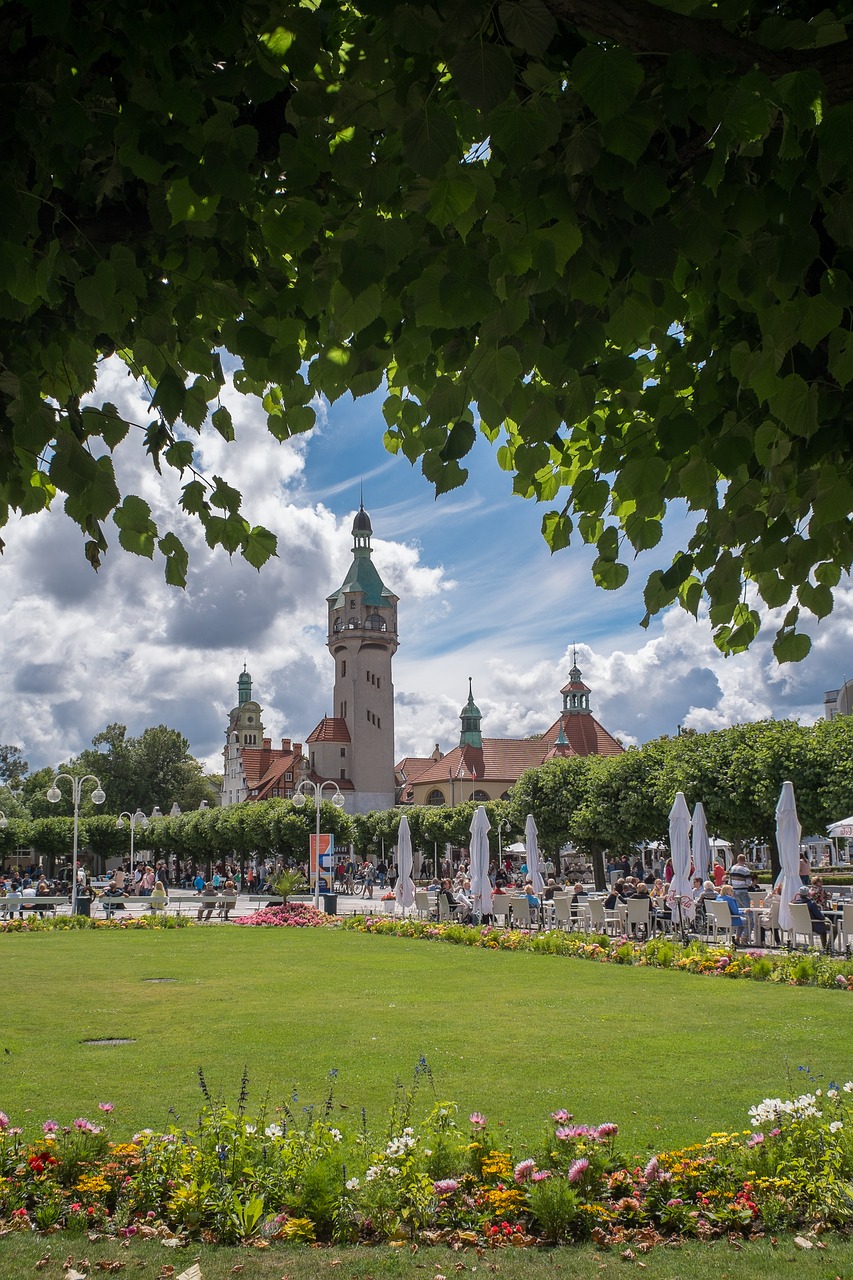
[0,0,853,660]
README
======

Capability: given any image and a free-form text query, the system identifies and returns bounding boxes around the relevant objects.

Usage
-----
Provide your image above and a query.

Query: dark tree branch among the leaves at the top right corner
[546,0,853,105]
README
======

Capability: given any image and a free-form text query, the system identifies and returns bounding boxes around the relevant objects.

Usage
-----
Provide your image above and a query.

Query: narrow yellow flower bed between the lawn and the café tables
[338,915,853,992]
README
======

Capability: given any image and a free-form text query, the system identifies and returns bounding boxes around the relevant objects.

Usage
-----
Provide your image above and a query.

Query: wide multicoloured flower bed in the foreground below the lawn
[0,1075,853,1245]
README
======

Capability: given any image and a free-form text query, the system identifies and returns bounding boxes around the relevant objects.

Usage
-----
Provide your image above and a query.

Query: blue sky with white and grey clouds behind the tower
[0,360,853,772]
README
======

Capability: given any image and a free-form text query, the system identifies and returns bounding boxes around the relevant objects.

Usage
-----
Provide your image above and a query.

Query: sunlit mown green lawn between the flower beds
[0,928,853,1151]
